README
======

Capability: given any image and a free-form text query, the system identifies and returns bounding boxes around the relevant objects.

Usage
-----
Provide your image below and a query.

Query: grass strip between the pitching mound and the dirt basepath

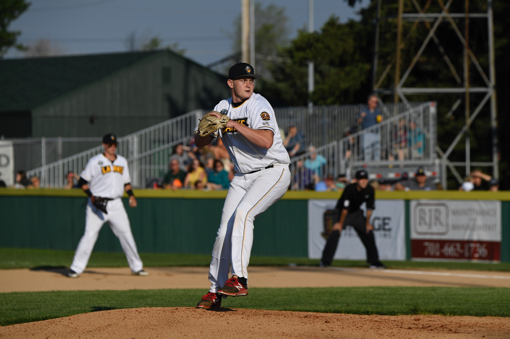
[0,287,510,326]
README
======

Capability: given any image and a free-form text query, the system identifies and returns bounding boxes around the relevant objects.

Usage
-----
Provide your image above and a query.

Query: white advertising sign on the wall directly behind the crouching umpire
[308,199,406,260]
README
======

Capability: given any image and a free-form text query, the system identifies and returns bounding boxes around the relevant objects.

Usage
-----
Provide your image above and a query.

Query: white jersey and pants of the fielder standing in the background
[71,154,143,274]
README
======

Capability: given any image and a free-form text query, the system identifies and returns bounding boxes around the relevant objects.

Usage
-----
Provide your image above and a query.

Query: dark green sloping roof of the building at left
[0,51,165,112]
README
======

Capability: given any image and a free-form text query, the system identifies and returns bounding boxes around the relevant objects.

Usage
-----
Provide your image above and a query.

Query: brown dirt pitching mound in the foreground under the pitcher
[0,308,510,339]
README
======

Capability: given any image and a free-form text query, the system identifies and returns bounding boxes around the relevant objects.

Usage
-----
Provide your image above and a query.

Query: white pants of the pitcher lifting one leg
[209,164,290,293]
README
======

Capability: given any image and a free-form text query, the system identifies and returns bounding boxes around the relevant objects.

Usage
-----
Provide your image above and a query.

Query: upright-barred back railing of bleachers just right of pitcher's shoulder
[275,103,422,147]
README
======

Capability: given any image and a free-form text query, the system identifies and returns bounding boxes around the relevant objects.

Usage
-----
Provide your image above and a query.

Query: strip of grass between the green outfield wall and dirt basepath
[0,248,510,271]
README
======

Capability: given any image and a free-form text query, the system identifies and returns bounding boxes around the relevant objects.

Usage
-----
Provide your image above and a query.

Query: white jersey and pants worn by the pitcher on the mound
[209,93,290,293]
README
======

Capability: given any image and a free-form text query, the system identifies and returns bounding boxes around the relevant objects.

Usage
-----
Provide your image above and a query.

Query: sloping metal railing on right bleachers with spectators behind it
[290,102,436,190]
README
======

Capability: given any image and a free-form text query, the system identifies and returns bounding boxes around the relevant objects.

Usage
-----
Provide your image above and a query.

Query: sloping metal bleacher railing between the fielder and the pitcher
[27,110,204,188]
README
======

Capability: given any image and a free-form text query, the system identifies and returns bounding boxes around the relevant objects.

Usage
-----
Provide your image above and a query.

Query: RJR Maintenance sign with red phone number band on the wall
[411,200,501,261]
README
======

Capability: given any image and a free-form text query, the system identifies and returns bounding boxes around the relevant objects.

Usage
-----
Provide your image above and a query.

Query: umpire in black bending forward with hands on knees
[320,170,385,268]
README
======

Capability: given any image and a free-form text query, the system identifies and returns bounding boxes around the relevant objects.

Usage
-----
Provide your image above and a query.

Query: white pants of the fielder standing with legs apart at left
[71,198,143,274]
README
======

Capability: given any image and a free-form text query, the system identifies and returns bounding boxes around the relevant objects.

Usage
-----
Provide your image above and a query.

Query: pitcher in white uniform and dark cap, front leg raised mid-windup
[195,63,291,309]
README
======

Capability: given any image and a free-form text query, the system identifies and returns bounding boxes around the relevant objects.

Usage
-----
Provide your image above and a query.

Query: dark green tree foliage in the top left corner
[0,0,30,57]
